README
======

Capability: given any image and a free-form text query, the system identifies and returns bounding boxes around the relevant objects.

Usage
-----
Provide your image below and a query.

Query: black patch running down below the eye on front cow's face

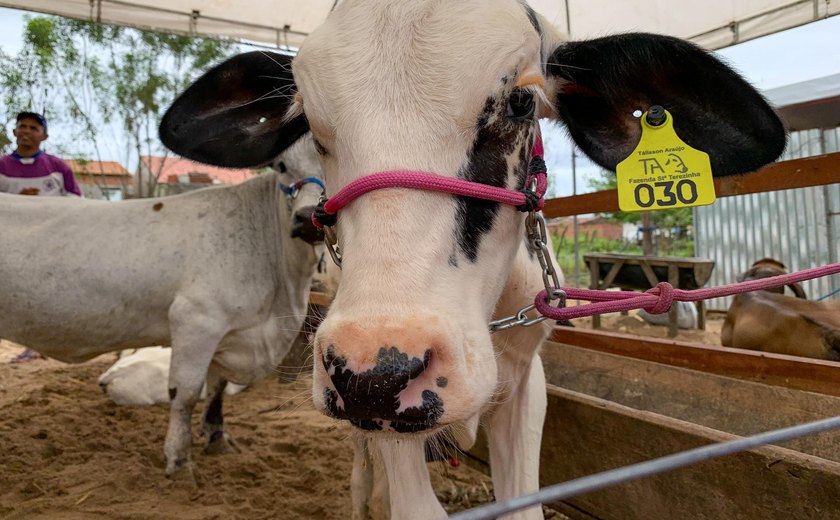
[456,97,531,262]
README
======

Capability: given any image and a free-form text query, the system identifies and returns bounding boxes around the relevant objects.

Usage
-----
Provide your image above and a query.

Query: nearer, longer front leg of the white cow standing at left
[164,311,224,483]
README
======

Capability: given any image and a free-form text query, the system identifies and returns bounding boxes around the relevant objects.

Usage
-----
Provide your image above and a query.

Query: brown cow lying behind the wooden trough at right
[720,258,840,361]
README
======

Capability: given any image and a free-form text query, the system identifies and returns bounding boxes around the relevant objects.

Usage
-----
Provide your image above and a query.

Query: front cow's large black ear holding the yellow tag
[547,33,786,176]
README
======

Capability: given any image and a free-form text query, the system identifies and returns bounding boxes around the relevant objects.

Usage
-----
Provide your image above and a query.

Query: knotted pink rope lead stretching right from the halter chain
[534,263,840,320]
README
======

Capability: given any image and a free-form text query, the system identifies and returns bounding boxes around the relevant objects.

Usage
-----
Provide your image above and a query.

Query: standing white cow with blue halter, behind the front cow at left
[0,140,321,478]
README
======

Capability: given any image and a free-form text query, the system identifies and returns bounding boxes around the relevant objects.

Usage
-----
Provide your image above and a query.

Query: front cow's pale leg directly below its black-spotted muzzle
[368,437,446,520]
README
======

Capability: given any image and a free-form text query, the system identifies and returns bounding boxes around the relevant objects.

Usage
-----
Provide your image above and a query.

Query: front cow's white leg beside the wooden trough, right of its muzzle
[487,355,548,520]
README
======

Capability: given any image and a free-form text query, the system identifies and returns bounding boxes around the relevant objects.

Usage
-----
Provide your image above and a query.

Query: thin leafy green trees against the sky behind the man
[0,16,236,194]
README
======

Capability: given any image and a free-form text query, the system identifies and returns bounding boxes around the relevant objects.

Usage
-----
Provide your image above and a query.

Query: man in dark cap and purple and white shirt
[0,112,82,197]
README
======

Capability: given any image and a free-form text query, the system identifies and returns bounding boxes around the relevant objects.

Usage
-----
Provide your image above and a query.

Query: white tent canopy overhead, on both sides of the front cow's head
[0,0,840,49]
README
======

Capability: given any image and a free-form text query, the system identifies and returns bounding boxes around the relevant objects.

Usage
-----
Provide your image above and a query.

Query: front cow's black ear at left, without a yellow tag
[160,51,309,168]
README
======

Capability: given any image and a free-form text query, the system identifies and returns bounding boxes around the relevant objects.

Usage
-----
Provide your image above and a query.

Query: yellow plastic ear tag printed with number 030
[616,107,715,212]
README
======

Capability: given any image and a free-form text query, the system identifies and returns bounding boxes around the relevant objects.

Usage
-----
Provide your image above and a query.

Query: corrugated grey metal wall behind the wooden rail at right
[694,128,840,311]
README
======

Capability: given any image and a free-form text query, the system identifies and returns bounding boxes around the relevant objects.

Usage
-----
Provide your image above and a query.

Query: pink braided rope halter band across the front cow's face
[312,132,548,229]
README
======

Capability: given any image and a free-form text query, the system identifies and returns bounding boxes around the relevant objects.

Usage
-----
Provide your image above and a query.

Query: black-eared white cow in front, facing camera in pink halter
[161,0,785,519]
